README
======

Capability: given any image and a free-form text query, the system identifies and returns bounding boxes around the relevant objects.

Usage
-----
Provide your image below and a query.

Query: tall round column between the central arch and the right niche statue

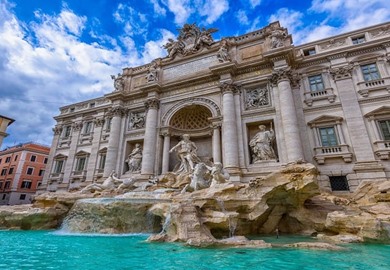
[220,83,238,170]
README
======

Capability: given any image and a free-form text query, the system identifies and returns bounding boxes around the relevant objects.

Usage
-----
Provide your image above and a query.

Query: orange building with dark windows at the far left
[0,143,50,205]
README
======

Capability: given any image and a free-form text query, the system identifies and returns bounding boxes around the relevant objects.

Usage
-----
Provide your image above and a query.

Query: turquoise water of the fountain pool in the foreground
[0,231,390,270]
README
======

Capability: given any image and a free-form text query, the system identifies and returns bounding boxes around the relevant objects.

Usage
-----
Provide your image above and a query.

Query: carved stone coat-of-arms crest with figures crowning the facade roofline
[163,23,218,58]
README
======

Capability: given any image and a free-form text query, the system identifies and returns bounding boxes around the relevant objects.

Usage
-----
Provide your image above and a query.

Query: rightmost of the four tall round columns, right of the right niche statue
[271,68,304,162]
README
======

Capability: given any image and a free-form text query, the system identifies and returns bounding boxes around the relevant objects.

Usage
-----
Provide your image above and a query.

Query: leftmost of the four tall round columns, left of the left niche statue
[104,106,125,177]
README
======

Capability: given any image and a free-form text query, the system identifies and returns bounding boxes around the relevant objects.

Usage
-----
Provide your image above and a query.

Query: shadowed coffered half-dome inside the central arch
[169,105,212,131]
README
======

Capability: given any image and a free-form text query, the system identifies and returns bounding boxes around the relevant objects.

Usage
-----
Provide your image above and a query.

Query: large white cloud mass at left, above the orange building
[0,1,173,146]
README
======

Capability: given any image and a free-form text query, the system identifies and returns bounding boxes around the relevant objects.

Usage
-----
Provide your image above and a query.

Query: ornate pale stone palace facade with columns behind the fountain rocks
[43,22,390,191]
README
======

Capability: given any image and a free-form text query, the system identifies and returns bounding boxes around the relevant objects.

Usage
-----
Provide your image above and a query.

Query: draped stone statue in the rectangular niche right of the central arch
[249,125,276,163]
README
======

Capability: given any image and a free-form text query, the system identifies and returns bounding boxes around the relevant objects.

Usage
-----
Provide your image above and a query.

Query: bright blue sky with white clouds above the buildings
[0,0,390,149]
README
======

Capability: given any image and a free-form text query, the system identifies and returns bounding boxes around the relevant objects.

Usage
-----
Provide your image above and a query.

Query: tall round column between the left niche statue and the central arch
[141,98,160,175]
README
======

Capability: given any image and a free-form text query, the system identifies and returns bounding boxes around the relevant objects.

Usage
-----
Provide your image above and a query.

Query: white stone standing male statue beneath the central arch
[169,134,200,174]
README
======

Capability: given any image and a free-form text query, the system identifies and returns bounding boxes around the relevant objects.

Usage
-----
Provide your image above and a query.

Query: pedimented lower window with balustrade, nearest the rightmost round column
[308,115,352,164]
